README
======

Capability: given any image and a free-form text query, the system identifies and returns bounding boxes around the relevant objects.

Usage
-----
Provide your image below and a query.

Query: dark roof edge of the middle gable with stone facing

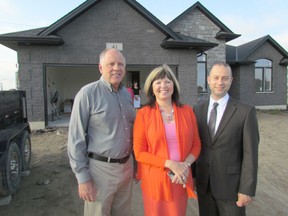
[167,1,241,42]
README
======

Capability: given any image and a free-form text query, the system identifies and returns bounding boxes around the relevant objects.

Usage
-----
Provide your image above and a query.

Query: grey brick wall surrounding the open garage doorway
[18,0,197,127]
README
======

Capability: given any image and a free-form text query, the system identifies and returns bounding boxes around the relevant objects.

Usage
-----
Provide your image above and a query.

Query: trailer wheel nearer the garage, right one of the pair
[20,131,31,171]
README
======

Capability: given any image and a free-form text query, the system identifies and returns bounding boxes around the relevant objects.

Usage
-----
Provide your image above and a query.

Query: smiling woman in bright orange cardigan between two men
[133,64,201,216]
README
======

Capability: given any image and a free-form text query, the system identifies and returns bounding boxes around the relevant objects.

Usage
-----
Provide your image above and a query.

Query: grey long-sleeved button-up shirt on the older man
[68,77,135,183]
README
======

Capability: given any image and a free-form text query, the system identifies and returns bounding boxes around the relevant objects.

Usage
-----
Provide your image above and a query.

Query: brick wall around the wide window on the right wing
[240,42,287,108]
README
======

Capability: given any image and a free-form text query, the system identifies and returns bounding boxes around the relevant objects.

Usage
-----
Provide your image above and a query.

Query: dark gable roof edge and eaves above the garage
[0,0,218,52]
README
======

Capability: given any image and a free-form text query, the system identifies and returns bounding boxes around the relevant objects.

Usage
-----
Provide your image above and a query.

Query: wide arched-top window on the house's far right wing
[255,59,273,92]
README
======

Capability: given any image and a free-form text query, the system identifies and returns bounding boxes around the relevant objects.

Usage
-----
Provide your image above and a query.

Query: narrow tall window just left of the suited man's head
[197,53,207,93]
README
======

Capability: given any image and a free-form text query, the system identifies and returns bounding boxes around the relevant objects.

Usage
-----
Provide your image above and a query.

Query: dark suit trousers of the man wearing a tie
[197,182,246,216]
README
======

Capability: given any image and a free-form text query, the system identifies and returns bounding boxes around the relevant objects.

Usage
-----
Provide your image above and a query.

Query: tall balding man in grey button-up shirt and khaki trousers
[68,48,135,216]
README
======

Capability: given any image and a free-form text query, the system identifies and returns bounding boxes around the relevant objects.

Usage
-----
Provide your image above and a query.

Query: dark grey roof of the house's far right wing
[226,35,288,65]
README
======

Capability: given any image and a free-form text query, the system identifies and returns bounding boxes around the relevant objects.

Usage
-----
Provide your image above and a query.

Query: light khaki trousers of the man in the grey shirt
[84,155,133,216]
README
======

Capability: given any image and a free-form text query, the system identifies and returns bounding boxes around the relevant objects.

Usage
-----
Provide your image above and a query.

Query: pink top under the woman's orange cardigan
[164,123,180,161]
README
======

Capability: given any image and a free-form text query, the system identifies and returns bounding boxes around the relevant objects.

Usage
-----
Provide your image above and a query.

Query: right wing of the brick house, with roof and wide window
[226,35,288,109]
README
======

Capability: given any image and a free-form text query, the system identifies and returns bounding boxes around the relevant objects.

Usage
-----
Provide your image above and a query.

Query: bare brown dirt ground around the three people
[0,111,288,216]
